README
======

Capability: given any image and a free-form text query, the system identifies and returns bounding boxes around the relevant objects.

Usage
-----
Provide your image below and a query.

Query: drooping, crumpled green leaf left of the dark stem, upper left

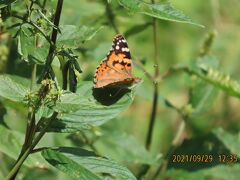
[17,27,49,64]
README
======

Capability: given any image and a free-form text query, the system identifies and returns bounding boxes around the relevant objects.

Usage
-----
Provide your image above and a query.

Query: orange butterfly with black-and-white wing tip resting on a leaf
[94,35,141,88]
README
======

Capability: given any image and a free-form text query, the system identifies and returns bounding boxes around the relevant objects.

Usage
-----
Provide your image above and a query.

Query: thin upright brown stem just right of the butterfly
[145,0,159,150]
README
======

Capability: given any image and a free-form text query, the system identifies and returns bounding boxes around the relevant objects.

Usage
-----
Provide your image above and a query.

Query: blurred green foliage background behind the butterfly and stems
[0,0,240,179]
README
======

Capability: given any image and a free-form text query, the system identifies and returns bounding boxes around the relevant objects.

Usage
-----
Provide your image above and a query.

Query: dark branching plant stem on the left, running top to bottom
[6,0,63,179]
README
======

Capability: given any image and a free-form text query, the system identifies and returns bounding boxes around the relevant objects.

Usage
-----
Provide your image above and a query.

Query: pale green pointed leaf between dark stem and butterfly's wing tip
[57,25,103,48]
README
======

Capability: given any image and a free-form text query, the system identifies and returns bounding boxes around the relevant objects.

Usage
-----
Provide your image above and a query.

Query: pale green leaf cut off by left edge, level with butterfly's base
[0,75,27,102]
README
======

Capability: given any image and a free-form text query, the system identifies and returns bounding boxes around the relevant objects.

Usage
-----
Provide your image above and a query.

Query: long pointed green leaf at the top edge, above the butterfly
[119,0,204,27]
